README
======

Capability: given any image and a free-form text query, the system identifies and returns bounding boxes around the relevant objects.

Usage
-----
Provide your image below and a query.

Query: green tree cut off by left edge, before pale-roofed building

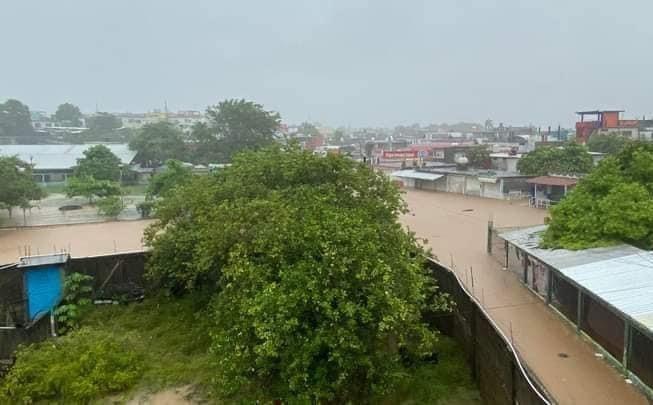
[0,157,45,216]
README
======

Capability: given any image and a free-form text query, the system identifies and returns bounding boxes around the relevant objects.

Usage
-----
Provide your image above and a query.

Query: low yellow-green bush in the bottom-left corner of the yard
[0,329,143,404]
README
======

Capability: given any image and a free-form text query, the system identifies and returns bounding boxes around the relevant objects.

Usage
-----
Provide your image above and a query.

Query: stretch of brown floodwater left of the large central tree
[0,220,152,264]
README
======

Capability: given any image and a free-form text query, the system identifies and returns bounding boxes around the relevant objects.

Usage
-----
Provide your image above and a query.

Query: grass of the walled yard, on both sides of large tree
[0,296,480,405]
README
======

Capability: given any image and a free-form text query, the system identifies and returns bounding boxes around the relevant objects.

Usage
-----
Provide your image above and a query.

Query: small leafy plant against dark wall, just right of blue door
[54,273,93,334]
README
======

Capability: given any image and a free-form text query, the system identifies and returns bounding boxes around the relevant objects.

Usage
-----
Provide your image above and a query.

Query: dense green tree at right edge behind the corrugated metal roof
[543,142,653,249]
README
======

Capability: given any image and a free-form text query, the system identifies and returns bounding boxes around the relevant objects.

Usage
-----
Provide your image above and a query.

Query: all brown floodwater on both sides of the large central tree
[0,190,646,404]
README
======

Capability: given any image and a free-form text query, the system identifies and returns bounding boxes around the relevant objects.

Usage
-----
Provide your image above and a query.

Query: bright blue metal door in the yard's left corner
[25,266,63,320]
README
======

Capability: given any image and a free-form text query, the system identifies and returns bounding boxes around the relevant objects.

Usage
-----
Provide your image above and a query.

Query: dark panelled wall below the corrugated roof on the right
[487,224,653,398]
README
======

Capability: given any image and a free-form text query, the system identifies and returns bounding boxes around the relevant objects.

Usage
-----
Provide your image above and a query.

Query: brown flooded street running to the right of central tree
[401,190,648,404]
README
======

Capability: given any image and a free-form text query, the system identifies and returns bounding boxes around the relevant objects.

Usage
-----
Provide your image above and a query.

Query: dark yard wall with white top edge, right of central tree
[428,260,551,405]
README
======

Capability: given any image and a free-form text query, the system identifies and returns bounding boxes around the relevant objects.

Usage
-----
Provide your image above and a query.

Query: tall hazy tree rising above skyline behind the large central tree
[191,99,280,163]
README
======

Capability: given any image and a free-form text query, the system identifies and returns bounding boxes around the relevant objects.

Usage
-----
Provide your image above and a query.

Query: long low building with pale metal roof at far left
[0,144,136,183]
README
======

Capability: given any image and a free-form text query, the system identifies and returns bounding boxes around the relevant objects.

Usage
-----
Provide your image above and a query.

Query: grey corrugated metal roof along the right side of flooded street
[499,225,653,331]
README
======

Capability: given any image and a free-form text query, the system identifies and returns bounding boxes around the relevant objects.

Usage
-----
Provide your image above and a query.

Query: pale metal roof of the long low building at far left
[0,144,136,170]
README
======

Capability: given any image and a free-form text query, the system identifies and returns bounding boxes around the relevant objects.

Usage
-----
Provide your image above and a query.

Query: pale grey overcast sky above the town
[0,0,653,126]
